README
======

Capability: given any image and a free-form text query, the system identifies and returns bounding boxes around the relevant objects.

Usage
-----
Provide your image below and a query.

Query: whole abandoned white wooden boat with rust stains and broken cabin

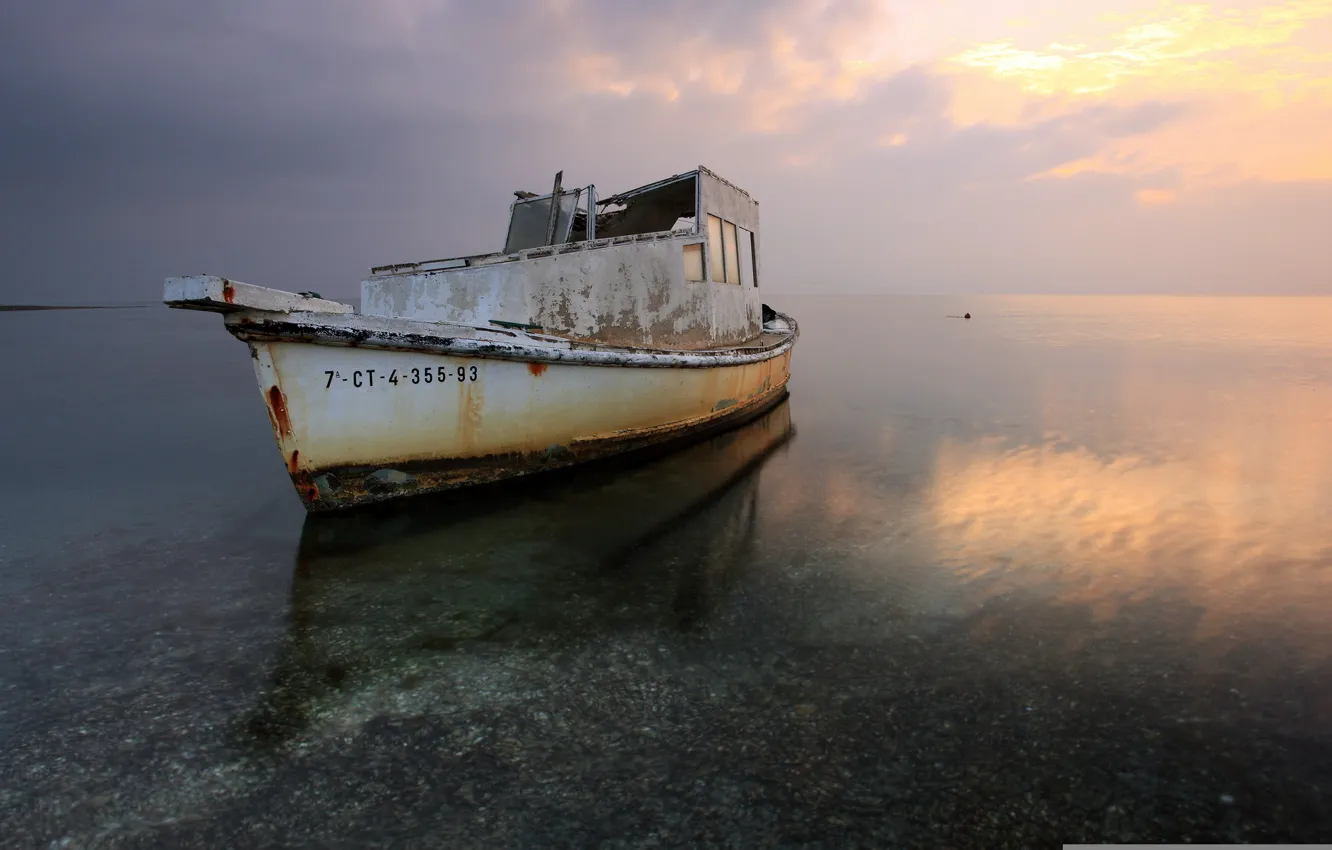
[164,167,799,512]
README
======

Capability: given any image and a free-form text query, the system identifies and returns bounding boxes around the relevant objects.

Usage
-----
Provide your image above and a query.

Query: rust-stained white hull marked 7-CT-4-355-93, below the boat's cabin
[228,313,794,510]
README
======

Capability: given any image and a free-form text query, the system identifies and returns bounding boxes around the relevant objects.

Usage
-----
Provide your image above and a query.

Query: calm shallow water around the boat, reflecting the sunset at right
[0,297,1332,847]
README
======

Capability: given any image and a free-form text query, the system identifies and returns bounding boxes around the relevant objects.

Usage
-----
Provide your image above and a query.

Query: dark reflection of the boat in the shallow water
[248,400,794,743]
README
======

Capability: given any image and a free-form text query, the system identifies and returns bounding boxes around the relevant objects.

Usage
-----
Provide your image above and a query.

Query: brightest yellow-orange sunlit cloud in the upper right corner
[946,0,1332,187]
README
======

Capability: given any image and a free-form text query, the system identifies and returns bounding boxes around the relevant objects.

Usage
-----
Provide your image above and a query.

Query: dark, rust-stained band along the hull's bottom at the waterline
[289,384,787,512]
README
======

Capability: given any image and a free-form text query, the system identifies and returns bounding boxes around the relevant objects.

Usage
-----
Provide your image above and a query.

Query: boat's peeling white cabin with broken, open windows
[361,167,762,350]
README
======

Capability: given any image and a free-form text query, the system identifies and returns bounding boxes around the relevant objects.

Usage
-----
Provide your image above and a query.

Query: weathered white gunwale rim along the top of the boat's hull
[225,310,799,369]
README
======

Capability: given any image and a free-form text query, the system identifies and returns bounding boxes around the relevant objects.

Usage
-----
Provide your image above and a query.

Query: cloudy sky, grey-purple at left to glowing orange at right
[0,0,1332,304]
